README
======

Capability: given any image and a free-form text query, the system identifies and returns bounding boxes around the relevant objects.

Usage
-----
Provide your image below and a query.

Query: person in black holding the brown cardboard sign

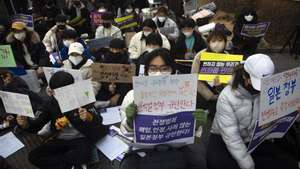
[96,39,132,106]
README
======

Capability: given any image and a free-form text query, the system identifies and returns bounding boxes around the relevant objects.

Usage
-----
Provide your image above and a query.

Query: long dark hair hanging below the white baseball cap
[231,64,250,90]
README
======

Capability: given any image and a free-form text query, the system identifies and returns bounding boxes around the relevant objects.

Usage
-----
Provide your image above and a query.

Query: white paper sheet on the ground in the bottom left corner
[0,132,24,158]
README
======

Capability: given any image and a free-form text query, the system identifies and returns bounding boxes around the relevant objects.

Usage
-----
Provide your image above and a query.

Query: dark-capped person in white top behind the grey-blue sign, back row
[95,13,123,39]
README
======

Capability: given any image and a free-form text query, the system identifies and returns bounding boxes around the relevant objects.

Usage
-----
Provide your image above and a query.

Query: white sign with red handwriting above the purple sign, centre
[133,74,197,114]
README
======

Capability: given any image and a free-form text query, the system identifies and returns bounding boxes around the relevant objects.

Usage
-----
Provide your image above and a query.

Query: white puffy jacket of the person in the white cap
[211,85,259,169]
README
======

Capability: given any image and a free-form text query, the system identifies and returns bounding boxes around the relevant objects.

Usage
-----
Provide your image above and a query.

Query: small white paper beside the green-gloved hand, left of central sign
[101,106,121,125]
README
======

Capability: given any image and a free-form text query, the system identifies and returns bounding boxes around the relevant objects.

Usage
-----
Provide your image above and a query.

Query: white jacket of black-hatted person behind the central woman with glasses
[128,31,171,59]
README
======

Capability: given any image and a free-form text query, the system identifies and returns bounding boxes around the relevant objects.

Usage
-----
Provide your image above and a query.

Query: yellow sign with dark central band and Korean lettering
[196,52,243,84]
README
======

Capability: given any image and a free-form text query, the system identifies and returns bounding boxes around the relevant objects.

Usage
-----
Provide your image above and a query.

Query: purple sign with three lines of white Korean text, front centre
[134,112,195,145]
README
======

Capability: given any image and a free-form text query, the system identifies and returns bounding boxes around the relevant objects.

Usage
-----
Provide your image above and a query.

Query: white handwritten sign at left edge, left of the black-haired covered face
[0,91,34,118]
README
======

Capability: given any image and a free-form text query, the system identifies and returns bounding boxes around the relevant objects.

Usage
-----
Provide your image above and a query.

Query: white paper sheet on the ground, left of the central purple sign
[96,135,129,161]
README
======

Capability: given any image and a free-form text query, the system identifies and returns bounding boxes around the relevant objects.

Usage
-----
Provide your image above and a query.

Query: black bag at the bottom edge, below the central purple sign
[120,145,188,169]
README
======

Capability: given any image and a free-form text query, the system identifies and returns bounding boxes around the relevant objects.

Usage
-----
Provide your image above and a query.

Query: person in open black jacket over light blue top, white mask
[172,18,206,60]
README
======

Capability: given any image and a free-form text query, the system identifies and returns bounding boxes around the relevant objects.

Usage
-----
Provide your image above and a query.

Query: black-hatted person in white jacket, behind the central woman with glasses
[128,19,171,61]
